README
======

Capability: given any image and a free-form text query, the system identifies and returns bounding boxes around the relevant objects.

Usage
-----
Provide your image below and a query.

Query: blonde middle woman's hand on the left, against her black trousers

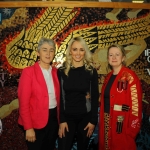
[58,122,69,138]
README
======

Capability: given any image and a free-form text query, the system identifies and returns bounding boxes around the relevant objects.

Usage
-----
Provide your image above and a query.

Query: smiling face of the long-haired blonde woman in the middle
[70,41,85,64]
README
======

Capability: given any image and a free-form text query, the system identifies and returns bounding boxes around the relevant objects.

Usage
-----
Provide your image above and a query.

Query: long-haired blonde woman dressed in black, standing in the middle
[58,37,99,150]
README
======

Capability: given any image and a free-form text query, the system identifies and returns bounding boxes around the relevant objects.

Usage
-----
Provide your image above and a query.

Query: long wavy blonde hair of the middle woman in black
[64,37,93,76]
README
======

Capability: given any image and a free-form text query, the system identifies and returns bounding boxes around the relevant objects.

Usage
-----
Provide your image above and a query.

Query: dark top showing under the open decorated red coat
[104,74,117,113]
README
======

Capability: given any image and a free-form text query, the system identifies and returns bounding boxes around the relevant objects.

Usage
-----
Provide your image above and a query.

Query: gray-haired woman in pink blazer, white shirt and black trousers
[18,38,60,150]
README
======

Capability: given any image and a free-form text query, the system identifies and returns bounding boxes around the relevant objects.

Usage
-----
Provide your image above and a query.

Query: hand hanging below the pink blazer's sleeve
[26,128,36,142]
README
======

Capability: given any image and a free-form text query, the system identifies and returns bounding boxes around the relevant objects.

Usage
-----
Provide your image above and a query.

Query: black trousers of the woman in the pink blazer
[23,108,58,150]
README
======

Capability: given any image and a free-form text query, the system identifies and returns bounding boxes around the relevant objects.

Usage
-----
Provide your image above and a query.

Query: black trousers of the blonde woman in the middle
[58,113,90,150]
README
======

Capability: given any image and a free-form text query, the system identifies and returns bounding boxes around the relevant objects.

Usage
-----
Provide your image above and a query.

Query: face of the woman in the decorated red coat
[108,47,125,68]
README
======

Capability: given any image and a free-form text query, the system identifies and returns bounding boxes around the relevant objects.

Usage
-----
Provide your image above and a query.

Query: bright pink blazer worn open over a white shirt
[18,62,60,130]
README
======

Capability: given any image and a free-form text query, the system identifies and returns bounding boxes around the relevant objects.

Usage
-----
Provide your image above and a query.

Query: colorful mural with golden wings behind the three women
[0,7,150,150]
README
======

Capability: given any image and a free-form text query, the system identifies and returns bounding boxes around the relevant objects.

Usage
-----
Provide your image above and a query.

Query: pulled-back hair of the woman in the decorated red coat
[107,44,126,70]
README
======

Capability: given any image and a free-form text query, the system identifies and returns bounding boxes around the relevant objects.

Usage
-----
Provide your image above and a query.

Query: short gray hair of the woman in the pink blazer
[37,37,56,52]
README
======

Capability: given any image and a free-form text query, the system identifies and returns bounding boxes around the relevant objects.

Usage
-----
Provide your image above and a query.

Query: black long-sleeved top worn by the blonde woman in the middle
[58,66,99,124]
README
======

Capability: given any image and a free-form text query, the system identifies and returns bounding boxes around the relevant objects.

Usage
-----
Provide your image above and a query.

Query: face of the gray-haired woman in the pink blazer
[37,42,55,68]
